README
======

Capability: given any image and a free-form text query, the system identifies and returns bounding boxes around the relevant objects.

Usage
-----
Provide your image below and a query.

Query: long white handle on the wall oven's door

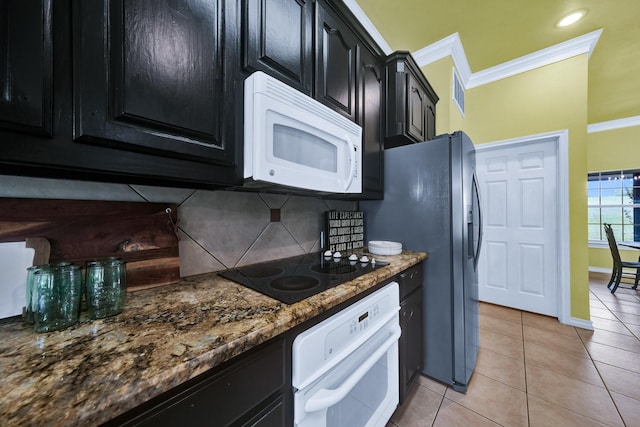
[304,325,402,413]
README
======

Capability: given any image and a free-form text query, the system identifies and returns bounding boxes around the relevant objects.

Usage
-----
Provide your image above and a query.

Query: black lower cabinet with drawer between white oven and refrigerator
[398,263,424,404]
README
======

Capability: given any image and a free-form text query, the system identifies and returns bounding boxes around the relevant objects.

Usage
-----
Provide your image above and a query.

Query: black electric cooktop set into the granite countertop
[218,252,389,304]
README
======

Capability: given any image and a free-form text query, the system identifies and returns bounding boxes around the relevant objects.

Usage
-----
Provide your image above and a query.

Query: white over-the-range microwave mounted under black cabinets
[244,71,362,193]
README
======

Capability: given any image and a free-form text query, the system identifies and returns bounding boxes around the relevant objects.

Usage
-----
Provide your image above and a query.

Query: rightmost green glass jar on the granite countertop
[85,258,127,319]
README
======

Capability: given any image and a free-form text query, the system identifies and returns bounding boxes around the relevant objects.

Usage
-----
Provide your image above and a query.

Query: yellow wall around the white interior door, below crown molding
[423,54,589,319]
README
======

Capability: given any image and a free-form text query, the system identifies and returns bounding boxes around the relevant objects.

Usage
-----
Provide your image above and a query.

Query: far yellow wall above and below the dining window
[587,126,640,269]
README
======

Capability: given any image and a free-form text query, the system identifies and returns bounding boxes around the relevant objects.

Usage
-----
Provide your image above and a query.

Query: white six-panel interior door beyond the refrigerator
[476,139,559,317]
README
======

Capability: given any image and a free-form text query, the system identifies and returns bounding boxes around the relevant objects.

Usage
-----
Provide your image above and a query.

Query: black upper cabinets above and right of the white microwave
[238,0,385,199]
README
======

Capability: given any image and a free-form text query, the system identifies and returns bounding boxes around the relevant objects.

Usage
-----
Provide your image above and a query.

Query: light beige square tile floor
[387,273,640,427]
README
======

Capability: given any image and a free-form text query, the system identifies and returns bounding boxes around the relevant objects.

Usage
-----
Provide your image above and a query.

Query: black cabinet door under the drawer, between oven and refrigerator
[399,288,423,403]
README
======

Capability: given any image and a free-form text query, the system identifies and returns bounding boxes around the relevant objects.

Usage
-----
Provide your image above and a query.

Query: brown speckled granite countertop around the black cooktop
[0,251,427,426]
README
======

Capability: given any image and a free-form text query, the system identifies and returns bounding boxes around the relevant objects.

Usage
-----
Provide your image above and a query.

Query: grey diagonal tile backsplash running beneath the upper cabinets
[0,176,358,277]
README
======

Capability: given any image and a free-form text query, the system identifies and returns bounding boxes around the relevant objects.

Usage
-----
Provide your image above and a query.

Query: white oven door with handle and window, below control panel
[294,313,400,427]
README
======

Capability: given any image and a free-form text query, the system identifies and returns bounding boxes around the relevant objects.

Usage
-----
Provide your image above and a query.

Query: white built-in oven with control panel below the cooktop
[292,282,400,427]
